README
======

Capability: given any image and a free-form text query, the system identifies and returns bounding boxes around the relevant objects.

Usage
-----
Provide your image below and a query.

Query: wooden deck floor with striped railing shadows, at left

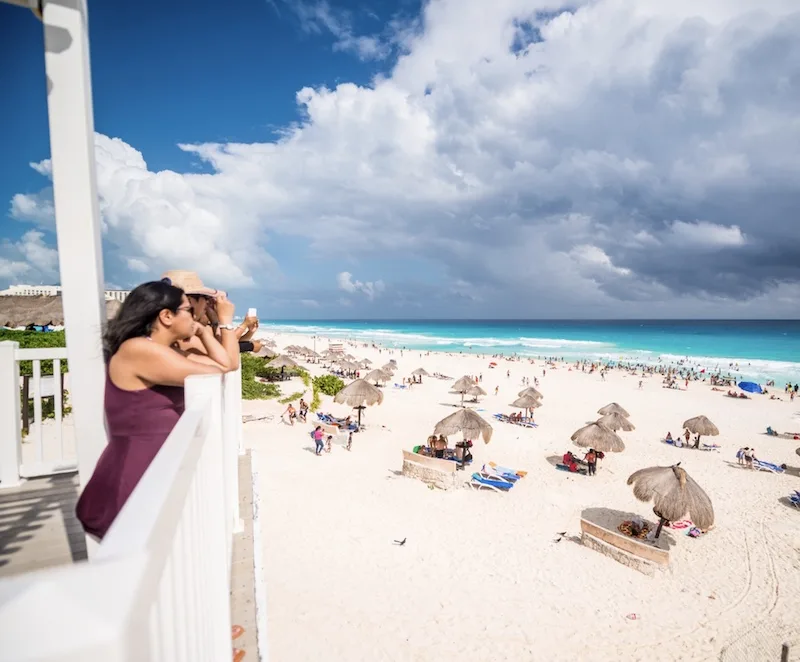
[0,474,87,572]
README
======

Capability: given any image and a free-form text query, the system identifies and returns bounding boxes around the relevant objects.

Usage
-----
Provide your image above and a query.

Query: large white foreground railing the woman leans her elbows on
[0,372,241,662]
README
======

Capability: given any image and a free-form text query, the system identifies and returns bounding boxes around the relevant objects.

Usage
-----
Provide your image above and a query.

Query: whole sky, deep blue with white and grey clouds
[0,0,800,319]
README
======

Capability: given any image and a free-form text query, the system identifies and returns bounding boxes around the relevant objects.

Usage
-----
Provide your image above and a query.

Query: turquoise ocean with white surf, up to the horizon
[261,320,800,386]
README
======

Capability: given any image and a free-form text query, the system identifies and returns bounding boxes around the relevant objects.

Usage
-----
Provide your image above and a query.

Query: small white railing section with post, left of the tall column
[0,341,78,488]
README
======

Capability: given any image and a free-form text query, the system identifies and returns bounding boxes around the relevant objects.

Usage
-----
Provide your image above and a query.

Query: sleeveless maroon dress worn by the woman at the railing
[76,373,184,538]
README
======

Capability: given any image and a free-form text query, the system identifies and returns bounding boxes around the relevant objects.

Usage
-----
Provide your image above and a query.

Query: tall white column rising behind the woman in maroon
[42,0,106,484]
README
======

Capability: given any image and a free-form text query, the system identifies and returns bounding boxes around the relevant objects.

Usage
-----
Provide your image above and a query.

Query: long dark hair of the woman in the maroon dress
[103,281,183,363]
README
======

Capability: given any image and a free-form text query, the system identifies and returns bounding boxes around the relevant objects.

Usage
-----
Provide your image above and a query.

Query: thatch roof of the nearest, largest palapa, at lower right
[628,464,714,530]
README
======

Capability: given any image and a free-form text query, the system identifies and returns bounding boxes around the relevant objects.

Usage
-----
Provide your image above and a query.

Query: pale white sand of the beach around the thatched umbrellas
[245,334,800,662]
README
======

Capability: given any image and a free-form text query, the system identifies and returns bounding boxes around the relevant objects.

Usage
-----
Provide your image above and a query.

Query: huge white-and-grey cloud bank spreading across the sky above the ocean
[7,0,800,316]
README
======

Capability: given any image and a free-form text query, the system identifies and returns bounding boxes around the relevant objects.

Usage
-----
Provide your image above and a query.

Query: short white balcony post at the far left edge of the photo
[0,341,22,489]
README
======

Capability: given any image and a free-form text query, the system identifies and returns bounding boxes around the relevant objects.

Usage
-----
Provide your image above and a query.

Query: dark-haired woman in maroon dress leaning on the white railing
[77,282,238,539]
